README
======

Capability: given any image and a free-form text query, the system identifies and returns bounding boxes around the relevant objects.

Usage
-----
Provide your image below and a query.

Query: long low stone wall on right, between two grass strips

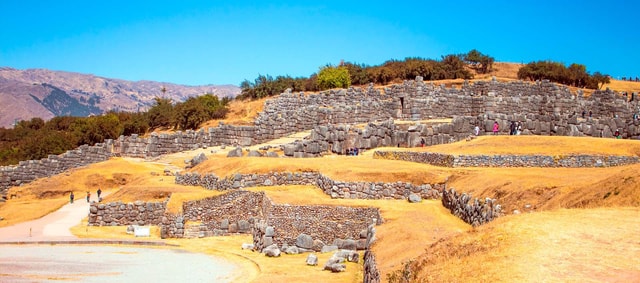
[373,151,640,168]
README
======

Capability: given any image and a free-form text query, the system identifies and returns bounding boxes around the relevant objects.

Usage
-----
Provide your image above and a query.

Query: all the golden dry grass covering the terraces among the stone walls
[0,64,640,282]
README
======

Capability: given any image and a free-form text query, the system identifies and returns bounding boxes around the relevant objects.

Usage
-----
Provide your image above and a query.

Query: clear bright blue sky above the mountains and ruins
[0,0,640,85]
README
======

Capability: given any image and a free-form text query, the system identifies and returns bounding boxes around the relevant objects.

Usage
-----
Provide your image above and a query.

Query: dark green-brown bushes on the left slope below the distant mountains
[0,94,229,165]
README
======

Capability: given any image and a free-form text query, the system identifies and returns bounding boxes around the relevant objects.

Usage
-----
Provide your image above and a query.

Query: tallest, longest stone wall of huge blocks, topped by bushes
[0,77,640,195]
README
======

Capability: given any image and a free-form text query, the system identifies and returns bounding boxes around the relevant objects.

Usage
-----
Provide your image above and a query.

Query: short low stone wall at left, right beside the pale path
[88,201,167,226]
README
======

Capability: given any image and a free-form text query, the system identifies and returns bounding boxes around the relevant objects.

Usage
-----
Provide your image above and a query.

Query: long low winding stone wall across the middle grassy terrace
[175,172,446,199]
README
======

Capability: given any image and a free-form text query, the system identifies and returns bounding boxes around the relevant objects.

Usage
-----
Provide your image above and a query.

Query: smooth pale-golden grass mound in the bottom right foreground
[400,207,640,282]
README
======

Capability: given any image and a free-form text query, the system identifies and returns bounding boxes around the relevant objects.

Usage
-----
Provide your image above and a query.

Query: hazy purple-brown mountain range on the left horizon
[0,67,240,128]
